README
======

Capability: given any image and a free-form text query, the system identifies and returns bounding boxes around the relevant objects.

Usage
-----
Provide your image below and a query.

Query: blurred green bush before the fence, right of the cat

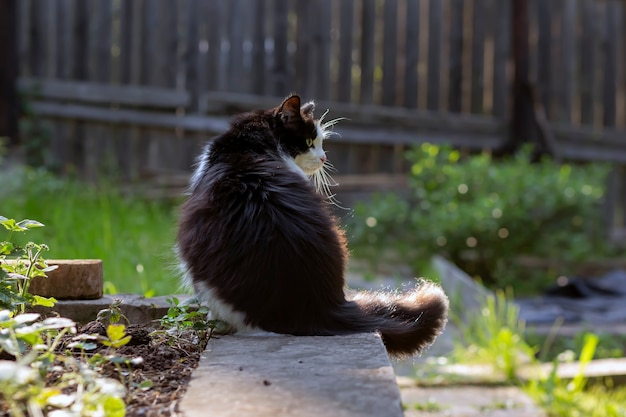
[348,144,611,294]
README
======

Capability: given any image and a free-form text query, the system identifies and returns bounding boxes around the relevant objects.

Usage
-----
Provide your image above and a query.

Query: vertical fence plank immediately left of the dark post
[492,0,513,119]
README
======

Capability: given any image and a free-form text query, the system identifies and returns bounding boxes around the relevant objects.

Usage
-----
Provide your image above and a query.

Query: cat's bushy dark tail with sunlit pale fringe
[340,281,449,357]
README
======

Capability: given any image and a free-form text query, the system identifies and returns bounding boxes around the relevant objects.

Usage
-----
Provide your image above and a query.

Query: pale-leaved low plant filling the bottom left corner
[0,310,125,417]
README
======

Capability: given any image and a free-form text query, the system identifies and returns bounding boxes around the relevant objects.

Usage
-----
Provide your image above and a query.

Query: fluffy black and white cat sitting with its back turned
[177,95,448,356]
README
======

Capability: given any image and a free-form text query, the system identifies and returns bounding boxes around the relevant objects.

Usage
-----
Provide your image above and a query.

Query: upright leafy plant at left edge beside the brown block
[0,216,56,313]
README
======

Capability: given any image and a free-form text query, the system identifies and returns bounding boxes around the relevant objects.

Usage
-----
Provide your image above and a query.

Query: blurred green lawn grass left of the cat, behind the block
[0,169,180,296]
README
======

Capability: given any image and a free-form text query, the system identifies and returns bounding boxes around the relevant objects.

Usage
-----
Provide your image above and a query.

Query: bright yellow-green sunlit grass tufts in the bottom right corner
[444,292,626,417]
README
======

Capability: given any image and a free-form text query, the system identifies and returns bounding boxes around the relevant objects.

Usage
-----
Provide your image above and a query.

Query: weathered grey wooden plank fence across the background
[12,0,626,184]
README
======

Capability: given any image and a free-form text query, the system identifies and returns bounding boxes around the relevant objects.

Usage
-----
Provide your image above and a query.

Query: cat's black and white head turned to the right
[274,95,326,176]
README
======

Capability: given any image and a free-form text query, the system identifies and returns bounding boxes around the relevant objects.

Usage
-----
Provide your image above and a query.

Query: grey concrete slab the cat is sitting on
[180,333,403,417]
